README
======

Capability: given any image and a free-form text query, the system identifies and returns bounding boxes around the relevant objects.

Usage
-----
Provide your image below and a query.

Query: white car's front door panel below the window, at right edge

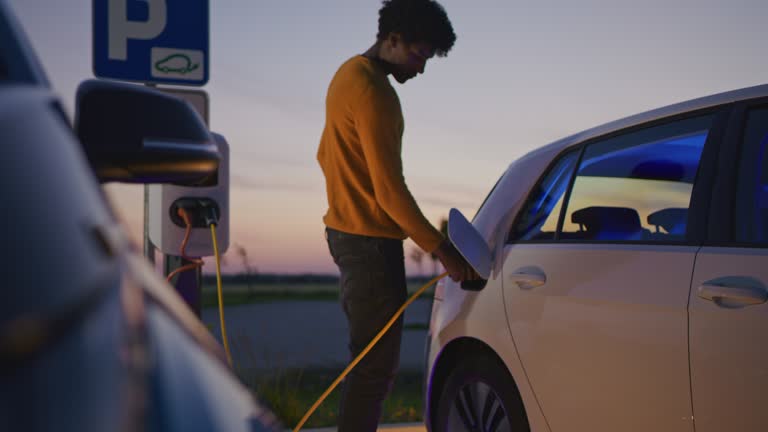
[690,247,768,432]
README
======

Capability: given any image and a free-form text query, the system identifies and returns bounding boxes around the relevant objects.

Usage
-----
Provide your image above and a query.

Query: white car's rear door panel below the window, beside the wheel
[504,244,697,432]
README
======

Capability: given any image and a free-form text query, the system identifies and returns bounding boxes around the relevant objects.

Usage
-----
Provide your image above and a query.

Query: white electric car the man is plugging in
[425,85,768,432]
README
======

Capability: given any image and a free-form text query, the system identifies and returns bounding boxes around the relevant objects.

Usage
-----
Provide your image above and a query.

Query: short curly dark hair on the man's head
[376,0,456,57]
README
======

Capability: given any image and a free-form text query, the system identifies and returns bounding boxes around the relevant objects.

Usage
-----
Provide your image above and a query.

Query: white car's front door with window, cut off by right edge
[690,101,768,432]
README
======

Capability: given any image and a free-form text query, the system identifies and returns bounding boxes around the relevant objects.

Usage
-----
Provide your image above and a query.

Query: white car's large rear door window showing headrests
[560,115,713,242]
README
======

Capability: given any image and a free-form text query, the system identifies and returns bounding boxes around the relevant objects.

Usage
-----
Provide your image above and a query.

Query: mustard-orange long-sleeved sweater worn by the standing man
[317,56,443,252]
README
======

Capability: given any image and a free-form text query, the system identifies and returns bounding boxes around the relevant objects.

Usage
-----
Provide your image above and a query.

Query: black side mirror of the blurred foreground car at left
[75,80,220,185]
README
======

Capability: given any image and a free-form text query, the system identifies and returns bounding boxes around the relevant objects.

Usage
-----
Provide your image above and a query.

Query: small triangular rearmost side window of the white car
[510,151,578,241]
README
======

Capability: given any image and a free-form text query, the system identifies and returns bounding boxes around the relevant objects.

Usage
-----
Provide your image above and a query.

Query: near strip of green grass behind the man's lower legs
[241,369,424,428]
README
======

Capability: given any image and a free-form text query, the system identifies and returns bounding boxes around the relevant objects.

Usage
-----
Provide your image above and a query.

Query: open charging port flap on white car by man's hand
[448,208,491,291]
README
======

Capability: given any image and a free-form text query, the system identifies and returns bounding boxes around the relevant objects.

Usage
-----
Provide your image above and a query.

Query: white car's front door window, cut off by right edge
[733,107,768,245]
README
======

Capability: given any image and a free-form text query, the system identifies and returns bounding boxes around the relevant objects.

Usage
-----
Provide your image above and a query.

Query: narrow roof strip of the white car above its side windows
[529,84,768,161]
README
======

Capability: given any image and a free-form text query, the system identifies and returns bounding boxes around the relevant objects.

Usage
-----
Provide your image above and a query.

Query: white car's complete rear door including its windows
[503,112,719,432]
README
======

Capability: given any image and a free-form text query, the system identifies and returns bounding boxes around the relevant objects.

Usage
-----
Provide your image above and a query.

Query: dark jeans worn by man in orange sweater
[326,228,407,432]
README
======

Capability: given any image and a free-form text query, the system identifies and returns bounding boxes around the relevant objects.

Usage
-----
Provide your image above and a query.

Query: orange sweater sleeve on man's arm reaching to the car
[353,85,443,253]
